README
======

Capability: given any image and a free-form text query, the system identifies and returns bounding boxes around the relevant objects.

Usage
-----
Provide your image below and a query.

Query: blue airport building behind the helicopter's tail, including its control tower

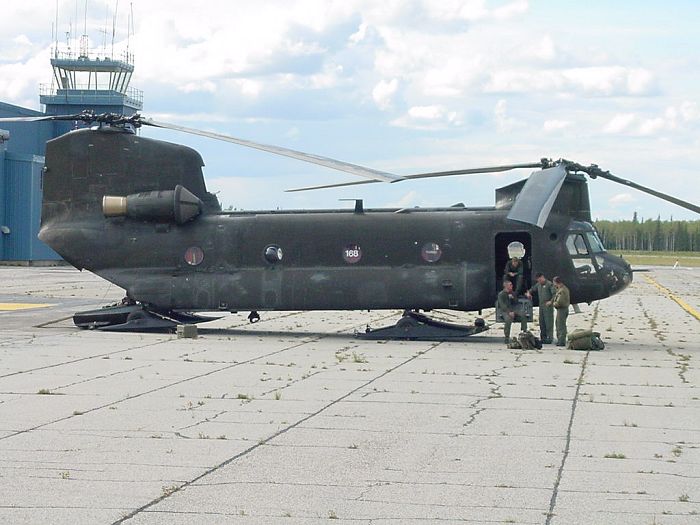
[0,44,143,261]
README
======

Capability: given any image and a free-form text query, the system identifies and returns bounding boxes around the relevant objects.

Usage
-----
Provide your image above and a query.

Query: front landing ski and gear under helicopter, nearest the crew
[355,310,489,341]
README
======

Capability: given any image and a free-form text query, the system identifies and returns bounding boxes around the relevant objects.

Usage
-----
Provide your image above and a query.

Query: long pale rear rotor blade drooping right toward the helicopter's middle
[141,119,403,182]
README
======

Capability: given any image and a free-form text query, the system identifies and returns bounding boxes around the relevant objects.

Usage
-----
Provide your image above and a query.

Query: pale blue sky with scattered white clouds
[0,0,700,220]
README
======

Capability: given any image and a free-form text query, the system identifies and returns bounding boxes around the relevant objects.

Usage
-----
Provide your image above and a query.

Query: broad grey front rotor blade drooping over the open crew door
[508,164,566,228]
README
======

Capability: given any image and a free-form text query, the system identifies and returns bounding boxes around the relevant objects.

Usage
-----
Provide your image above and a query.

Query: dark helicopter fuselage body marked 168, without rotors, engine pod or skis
[35,126,631,311]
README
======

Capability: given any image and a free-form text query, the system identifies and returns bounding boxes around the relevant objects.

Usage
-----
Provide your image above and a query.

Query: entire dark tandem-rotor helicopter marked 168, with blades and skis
[0,111,700,339]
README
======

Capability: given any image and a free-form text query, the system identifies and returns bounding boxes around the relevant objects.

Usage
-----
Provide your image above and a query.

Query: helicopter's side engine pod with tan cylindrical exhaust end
[102,184,202,224]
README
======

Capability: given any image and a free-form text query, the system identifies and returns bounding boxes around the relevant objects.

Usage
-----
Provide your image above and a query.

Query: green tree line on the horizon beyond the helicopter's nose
[593,212,700,252]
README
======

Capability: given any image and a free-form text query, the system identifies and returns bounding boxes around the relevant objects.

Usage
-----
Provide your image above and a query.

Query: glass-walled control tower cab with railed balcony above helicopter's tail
[39,35,143,131]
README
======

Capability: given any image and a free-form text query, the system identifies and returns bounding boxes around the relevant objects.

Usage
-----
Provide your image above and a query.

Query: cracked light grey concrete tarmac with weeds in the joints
[0,267,700,525]
